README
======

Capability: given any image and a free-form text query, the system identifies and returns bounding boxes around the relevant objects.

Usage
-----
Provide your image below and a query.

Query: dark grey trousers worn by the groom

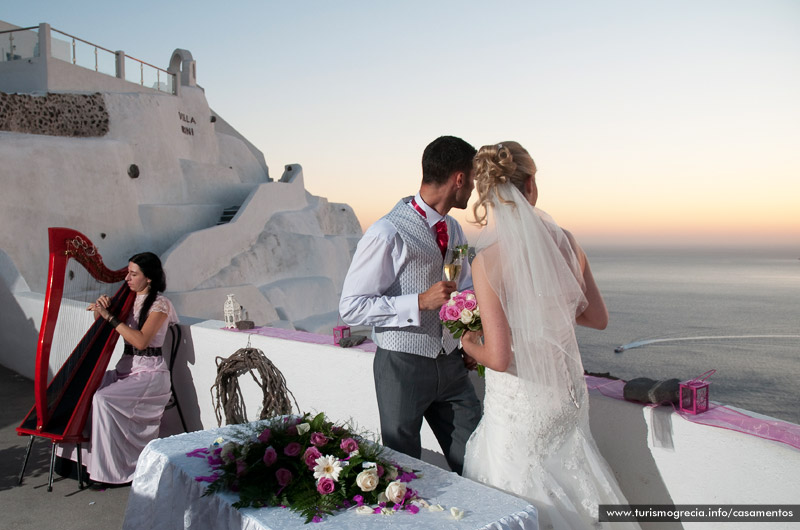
[372,347,481,474]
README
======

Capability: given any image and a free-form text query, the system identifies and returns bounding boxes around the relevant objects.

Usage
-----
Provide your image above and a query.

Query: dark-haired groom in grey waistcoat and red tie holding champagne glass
[339,136,481,474]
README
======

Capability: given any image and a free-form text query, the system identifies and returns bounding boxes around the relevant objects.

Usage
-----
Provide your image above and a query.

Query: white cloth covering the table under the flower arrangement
[123,420,538,530]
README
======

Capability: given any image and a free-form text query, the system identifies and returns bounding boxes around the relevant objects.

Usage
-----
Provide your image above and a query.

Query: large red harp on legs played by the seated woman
[17,228,135,491]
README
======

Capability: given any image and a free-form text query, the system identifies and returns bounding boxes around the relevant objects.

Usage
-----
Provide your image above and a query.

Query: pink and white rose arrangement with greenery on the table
[187,413,425,523]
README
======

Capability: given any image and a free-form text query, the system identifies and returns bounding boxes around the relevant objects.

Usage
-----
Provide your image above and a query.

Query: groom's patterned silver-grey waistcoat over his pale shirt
[375,197,458,357]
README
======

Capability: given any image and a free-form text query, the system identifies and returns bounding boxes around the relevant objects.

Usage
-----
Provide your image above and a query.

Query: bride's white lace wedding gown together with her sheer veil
[463,184,639,530]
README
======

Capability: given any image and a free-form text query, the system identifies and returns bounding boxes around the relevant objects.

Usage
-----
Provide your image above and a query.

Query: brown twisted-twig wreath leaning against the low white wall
[211,344,300,426]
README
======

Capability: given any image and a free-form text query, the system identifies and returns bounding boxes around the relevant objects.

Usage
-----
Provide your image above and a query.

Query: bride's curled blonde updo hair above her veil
[472,142,536,226]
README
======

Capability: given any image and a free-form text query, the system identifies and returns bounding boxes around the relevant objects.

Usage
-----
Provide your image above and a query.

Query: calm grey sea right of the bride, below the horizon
[578,245,800,424]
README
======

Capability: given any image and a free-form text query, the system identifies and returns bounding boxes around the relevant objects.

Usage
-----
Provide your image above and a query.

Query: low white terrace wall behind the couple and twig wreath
[0,289,800,530]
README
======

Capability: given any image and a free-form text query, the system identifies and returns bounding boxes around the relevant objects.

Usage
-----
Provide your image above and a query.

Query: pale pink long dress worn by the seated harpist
[59,294,178,484]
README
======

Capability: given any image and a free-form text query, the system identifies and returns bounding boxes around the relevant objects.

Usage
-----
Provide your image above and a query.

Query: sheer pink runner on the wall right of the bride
[586,375,800,449]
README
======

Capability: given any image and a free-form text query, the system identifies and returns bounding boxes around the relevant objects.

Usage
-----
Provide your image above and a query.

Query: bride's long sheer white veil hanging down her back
[476,183,586,410]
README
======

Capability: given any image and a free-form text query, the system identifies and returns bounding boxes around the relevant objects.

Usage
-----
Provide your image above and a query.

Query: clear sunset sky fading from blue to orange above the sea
[6,0,800,246]
